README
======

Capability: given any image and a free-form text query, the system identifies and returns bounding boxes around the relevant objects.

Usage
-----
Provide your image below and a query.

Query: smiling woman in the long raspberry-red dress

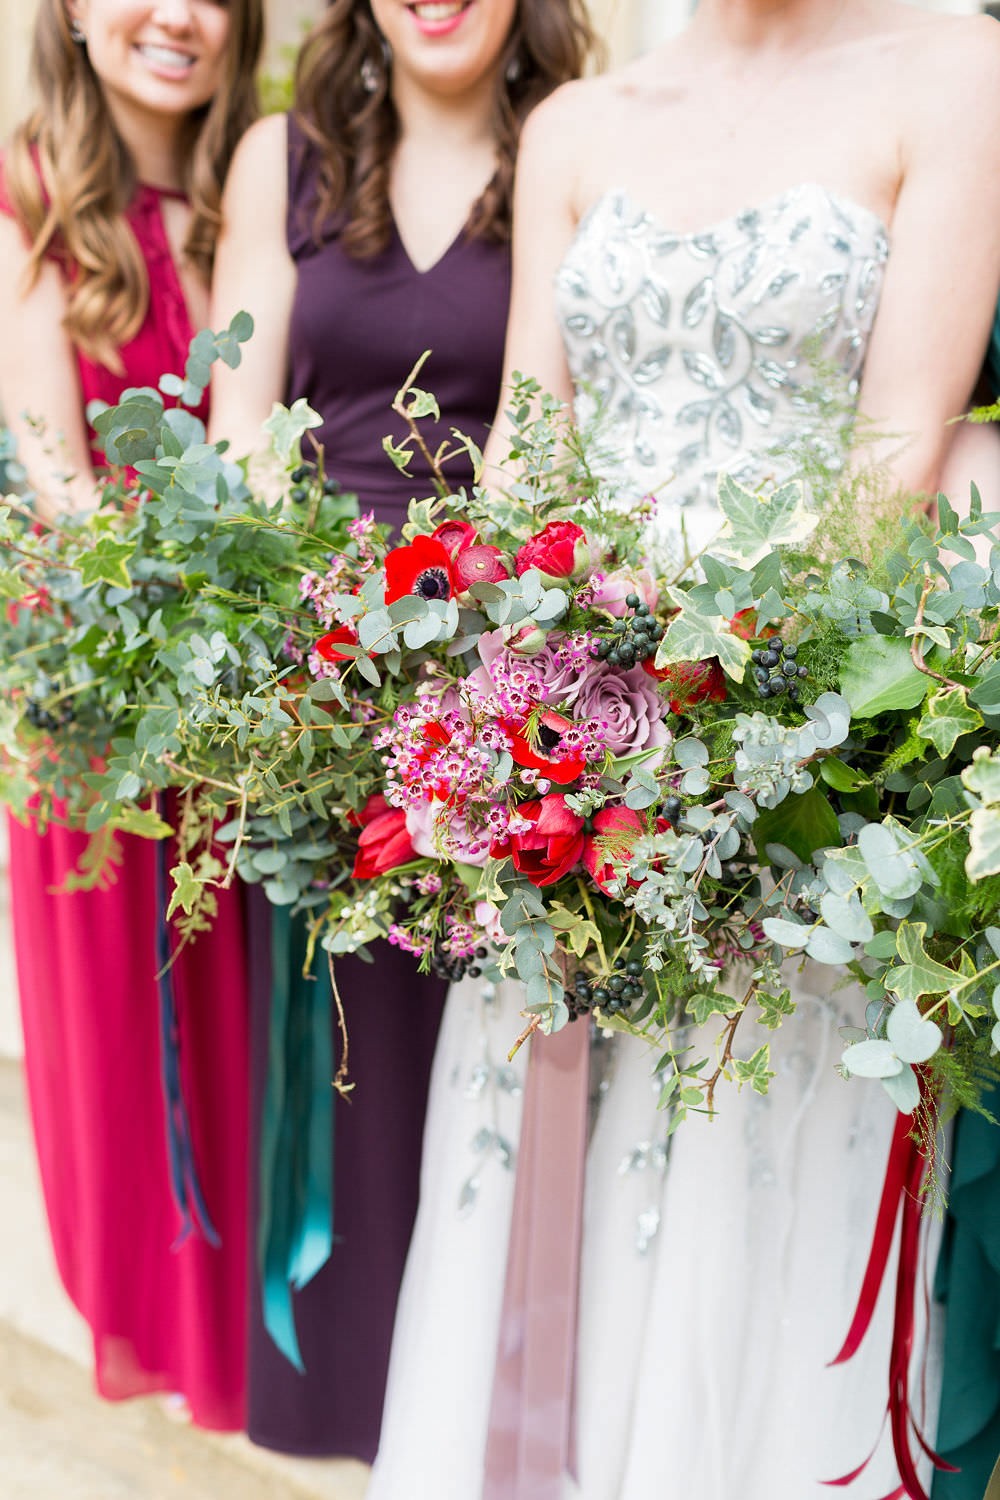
[0,0,262,1430]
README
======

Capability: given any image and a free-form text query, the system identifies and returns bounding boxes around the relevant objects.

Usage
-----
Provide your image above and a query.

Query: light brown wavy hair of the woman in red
[4,0,264,369]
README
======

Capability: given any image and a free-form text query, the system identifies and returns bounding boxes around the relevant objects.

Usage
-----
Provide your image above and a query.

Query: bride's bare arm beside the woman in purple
[486,86,579,470]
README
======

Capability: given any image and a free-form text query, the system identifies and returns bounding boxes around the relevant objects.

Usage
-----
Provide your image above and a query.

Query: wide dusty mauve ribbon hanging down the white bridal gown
[483,1022,589,1500]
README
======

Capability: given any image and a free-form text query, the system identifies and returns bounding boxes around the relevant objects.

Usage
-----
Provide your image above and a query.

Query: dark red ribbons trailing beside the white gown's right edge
[823,1115,957,1500]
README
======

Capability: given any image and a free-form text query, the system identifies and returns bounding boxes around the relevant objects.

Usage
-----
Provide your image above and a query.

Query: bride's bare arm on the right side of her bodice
[861,20,1000,494]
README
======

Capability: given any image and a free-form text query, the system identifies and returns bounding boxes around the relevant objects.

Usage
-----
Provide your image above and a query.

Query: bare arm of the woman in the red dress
[0,216,96,516]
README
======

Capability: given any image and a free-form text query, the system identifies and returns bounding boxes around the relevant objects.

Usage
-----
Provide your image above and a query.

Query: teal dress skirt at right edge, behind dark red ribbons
[931,1089,1000,1500]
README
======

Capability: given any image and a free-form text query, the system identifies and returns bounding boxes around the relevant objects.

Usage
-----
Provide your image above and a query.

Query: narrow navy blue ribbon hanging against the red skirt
[156,797,222,1248]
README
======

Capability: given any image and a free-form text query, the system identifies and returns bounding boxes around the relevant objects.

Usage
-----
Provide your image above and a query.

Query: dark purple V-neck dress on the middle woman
[239,119,510,1460]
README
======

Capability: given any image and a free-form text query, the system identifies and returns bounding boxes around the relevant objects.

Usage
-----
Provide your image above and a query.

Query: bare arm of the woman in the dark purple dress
[210,116,295,458]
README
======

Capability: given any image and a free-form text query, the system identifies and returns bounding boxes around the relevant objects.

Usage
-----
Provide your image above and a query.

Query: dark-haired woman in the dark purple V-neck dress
[206,0,591,1460]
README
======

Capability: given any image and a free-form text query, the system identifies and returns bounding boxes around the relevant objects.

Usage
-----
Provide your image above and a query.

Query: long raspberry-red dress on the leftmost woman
[0,164,247,1430]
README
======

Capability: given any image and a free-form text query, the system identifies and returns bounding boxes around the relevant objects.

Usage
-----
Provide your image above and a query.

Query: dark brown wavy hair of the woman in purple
[295,0,595,258]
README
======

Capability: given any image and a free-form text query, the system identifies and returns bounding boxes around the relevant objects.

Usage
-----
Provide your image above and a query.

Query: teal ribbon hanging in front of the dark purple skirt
[256,906,334,1373]
